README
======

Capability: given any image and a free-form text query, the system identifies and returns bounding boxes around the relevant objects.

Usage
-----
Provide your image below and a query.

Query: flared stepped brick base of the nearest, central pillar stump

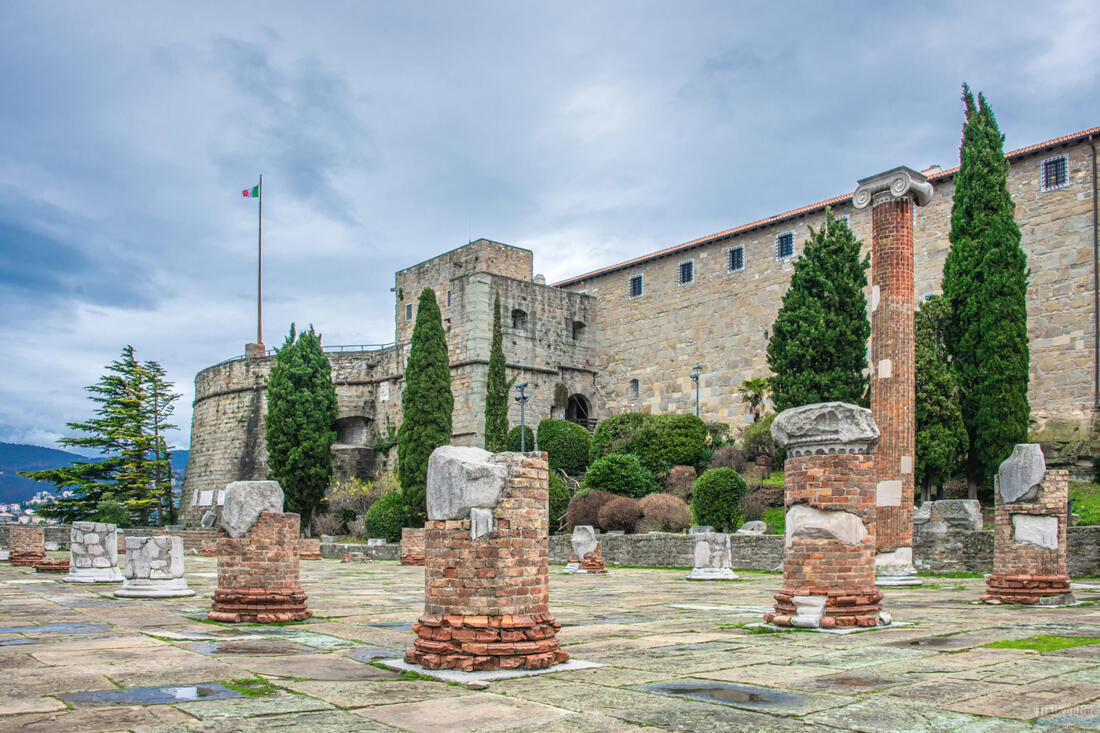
[405,613,569,671]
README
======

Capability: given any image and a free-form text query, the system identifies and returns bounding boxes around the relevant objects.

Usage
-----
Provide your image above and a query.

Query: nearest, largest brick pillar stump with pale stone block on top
[405,446,569,671]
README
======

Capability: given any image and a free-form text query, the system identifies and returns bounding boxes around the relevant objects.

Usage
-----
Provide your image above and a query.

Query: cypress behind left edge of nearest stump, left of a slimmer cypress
[397,287,454,526]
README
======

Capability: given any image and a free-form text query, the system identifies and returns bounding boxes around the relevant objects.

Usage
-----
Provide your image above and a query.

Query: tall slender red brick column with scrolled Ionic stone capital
[851,166,932,586]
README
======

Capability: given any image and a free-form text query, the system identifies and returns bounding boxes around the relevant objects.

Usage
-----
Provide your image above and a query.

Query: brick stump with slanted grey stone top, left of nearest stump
[207,481,314,624]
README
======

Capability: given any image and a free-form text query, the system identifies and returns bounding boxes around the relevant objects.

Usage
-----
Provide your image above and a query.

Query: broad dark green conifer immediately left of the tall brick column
[768,209,871,412]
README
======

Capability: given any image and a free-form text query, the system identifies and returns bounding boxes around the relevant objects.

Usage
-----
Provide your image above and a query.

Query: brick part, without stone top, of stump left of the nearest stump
[207,512,312,624]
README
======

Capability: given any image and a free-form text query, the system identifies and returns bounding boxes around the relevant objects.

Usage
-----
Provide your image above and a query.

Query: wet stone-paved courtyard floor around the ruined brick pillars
[0,557,1100,733]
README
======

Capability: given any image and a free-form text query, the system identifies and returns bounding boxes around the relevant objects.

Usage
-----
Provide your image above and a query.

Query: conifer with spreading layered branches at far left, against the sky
[20,346,170,524]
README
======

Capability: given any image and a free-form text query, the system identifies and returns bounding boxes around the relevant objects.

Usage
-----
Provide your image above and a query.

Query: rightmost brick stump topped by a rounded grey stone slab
[981,444,1074,605]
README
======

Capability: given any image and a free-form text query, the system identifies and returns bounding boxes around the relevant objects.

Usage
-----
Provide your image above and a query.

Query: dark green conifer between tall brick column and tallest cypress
[914,295,967,501]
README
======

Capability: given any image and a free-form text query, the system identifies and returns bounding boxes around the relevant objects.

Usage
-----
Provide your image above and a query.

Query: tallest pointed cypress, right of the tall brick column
[943,85,1031,499]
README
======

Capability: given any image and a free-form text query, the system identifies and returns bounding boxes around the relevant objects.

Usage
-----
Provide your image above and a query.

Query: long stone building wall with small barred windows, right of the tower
[559,134,1100,455]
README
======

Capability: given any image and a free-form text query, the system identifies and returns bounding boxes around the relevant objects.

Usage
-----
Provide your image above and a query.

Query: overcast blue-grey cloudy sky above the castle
[0,0,1100,447]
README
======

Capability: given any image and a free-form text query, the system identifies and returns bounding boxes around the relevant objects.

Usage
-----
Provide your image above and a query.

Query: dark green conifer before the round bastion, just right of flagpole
[264,324,337,536]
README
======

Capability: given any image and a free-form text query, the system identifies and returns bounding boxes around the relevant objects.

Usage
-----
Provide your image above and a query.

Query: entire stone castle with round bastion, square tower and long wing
[183,128,1100,526]
